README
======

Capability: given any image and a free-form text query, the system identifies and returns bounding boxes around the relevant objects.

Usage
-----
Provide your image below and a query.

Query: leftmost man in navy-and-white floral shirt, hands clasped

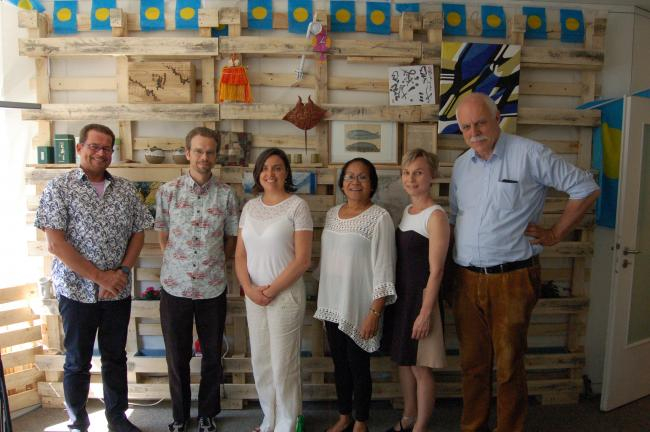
[34,124,153,432]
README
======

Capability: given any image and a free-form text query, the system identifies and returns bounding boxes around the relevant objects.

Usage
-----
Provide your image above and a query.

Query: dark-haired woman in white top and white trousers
[235,148,313,432]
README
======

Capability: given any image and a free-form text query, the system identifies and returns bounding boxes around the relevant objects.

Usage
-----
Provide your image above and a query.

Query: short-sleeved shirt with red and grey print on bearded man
[155,174,239,300]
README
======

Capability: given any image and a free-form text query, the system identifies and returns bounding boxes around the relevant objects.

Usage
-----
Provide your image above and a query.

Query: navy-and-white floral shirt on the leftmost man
[34,168,153,303]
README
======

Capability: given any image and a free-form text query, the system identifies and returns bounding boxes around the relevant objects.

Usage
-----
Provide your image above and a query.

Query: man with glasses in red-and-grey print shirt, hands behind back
[155,127,238,432]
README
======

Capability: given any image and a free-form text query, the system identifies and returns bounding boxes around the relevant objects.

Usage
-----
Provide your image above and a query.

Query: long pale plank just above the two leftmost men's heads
[22,104,219,122]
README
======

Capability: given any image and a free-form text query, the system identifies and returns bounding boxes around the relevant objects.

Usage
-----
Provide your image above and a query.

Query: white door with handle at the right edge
[600,96,650,411]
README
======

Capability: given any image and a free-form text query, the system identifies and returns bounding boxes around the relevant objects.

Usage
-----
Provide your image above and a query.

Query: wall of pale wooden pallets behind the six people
[12,1,606,408]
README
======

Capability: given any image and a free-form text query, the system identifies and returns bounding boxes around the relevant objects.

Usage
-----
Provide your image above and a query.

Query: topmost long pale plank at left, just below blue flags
[18,37,219,57]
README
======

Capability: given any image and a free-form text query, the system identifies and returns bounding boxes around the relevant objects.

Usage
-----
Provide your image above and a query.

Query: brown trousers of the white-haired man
[453,260,540,432]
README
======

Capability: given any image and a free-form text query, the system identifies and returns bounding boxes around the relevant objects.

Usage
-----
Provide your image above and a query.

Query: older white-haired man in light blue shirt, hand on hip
[449,93,599,432]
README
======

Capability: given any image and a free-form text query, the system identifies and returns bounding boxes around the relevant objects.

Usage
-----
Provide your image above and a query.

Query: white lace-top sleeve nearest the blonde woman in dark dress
[371,212,397,305]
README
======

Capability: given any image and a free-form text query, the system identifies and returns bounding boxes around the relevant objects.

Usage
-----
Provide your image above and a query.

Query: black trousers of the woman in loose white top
[325,321,372,421]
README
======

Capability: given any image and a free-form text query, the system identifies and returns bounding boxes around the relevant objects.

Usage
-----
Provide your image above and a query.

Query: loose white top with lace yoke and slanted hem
[314,204,397,352]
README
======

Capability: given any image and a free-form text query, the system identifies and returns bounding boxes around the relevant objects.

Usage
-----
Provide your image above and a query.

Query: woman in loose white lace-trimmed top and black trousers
[314,158,395,432]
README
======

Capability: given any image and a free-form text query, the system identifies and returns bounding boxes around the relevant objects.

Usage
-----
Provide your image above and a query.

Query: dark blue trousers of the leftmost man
[59,296,131,430]
